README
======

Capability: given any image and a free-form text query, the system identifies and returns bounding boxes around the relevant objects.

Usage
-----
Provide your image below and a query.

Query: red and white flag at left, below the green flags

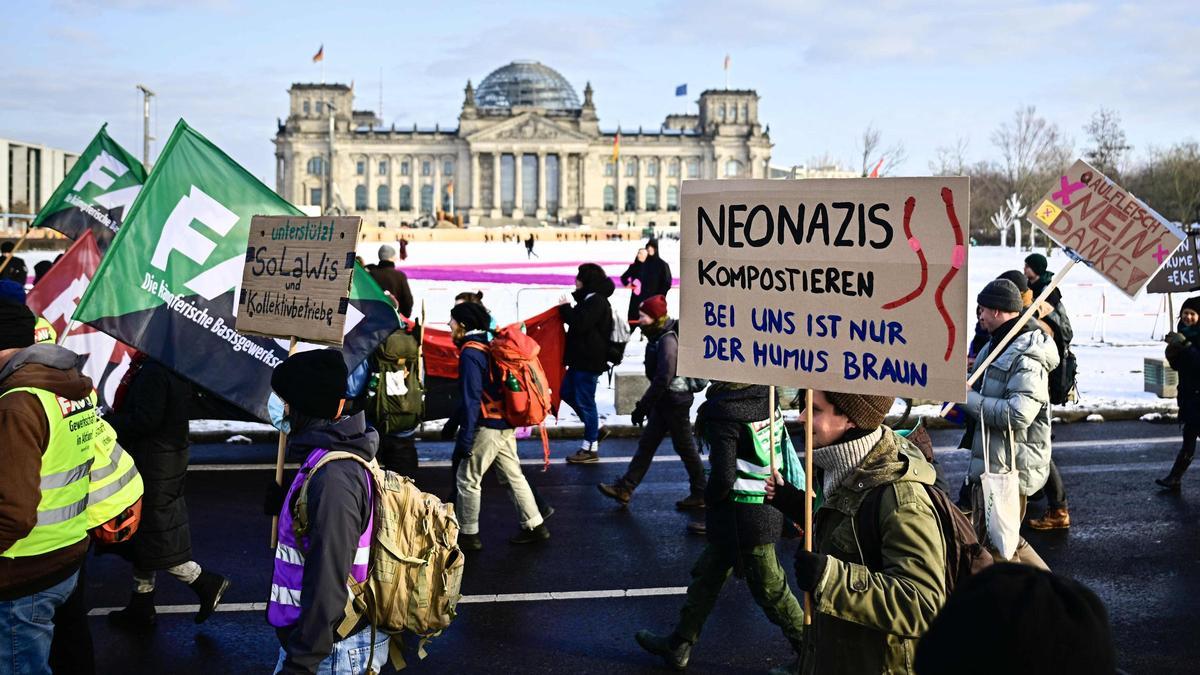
[25,229,137,407]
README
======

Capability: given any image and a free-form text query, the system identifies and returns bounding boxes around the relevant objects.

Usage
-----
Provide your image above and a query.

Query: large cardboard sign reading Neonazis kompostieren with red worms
[678,178,971,401]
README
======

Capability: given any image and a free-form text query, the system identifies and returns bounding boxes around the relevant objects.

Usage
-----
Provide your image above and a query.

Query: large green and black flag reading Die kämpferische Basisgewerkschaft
[74,120,400,419]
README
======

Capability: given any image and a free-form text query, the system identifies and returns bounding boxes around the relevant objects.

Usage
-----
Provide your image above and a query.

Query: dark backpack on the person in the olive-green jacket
[856,483,994,596]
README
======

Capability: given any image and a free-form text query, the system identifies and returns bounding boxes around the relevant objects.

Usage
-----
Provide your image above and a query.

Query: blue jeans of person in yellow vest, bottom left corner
[0,571,79,675]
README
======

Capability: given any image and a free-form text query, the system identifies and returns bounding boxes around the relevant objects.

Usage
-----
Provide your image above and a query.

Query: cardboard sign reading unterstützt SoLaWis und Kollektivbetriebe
[236,216,362,347]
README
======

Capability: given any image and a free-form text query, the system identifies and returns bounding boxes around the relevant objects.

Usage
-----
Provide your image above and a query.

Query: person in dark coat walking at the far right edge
[1154,295,1200,491]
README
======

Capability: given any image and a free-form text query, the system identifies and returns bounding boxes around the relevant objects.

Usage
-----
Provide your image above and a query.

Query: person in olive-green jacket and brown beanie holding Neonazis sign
[767,392,946,675]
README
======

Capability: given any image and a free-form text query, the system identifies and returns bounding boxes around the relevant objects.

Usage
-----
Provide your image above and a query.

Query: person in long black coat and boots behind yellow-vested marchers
[104,356,229,628]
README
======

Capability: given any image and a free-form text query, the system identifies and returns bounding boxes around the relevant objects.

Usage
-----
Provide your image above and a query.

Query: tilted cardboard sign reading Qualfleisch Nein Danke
[1027,160,1183,298]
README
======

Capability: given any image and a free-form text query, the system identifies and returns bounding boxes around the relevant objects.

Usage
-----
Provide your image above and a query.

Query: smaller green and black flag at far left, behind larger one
[30,124,146,251]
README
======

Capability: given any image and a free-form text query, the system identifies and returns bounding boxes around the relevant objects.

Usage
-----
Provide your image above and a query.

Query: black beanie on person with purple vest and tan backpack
[271,350,348,419]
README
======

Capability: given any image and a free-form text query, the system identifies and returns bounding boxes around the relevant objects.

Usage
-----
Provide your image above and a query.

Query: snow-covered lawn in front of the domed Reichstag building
[22,237,1182,431]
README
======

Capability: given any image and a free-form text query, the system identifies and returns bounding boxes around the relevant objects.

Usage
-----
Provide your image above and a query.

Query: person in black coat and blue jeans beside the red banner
[558,263,616,464]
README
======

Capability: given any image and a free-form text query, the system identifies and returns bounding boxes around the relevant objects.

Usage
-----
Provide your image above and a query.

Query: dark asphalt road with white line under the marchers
[79,422,1200,675]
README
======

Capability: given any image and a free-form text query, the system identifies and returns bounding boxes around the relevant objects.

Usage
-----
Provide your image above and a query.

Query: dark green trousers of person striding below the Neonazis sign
[674,544,804,650]
